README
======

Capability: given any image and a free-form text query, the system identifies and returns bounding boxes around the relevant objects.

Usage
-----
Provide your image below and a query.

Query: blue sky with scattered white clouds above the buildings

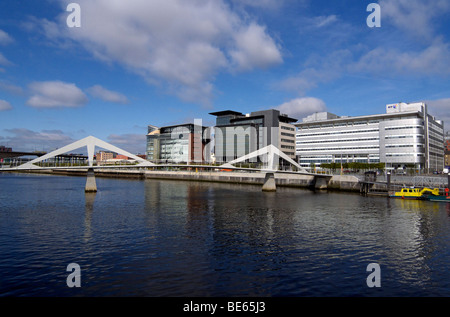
[0,0,450,153]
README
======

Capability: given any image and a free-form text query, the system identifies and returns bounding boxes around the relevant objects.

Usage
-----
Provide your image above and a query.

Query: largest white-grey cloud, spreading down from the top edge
[42,0,282,103]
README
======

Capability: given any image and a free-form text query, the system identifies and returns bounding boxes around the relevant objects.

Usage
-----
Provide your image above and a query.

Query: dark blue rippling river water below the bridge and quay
[0,174,450,297]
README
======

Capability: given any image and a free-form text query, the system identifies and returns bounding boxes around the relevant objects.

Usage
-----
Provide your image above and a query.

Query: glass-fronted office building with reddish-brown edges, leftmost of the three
[146,123,210,164]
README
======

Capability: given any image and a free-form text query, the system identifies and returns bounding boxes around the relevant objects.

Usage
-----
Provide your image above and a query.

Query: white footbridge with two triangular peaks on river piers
[0,136,332,191]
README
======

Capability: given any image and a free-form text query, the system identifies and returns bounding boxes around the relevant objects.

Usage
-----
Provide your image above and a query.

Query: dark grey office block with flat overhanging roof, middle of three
[210,109,297,162]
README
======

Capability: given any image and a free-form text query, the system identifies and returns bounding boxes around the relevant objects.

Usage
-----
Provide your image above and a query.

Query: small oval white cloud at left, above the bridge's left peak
[27,81,88,108]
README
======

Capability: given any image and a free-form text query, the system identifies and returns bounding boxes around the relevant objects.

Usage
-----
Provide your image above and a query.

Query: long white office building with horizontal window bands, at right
[296,103,444,171]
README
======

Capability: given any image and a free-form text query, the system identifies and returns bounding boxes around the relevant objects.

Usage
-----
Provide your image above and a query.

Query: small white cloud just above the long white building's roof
[276,97,327,121]
